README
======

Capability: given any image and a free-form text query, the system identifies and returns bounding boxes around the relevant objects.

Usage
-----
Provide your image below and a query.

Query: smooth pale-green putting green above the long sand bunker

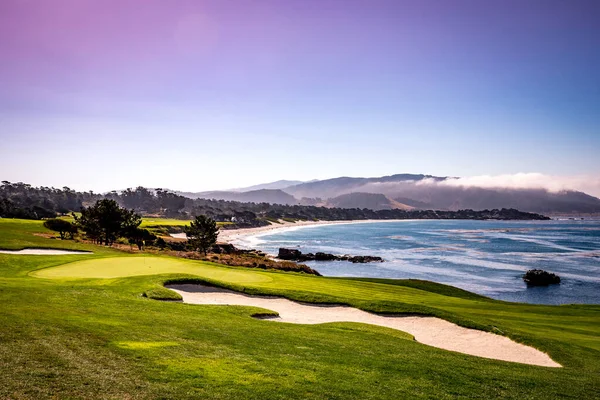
[31,256,271,283]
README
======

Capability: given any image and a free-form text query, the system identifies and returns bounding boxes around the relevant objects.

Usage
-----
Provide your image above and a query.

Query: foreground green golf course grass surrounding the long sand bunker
[0,220,600,399]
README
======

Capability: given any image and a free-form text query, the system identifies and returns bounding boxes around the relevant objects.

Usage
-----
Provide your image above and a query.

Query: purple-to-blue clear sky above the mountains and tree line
[0,0,600,195]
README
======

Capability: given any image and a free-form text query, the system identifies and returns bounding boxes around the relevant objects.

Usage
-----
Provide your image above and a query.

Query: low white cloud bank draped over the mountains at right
[417,172,600,197]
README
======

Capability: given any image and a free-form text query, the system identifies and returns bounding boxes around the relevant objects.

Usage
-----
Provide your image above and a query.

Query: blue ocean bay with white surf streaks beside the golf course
[235,220,600,304]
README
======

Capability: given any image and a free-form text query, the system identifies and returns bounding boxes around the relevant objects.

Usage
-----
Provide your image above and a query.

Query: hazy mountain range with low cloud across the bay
[179,174,600,214]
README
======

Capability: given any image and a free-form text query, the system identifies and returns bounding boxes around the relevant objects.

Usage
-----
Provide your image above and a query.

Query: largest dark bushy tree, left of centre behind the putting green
[76,199,142,246]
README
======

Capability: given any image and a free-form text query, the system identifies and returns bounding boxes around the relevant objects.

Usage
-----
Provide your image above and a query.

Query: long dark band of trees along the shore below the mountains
[0,181,548,230]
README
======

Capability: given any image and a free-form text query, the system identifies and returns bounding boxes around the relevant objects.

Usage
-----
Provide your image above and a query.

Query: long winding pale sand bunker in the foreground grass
[167,284,561,367]
